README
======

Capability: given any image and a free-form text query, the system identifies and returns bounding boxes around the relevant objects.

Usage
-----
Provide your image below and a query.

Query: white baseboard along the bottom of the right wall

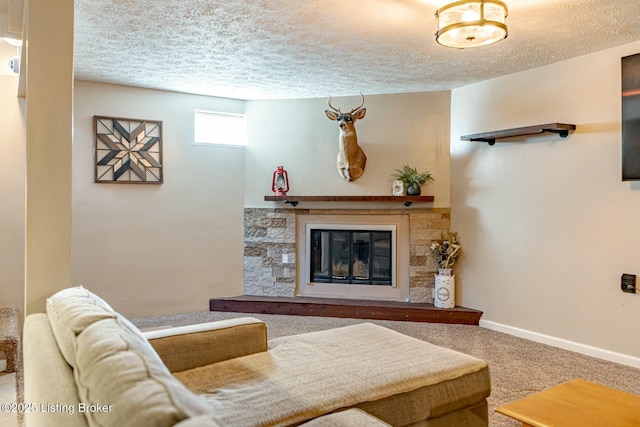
[480,319,640,369]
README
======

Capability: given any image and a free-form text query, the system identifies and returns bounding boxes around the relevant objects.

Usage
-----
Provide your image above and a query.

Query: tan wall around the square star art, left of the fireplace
[73,81,244,317]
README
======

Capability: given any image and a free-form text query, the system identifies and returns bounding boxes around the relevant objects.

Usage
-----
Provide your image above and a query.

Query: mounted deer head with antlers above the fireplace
[324,94,367,181]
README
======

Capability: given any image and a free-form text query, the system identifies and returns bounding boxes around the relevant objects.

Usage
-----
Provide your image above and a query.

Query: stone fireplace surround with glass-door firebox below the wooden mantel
[244,207,450,303]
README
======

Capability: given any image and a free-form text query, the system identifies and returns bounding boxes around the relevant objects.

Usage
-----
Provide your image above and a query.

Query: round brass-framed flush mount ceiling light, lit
[436,0,508,49]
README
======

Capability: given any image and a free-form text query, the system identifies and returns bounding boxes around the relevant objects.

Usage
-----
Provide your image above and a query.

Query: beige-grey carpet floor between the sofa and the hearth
[133,312,640,427]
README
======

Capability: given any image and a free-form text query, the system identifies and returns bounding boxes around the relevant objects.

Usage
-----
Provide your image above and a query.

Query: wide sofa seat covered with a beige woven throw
[174,323,490,427]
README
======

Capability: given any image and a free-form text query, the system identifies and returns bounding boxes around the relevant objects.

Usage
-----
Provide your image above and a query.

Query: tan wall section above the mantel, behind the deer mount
[245,91,450,208]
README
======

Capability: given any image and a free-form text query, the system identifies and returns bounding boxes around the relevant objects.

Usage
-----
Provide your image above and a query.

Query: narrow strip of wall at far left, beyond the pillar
[0,40,26,311]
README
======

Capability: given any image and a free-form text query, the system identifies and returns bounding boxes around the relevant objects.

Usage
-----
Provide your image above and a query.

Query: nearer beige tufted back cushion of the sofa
[74,317,208,427]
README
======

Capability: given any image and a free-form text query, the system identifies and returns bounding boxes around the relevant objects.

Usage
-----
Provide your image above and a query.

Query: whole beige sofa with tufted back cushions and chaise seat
[23,287,490,427]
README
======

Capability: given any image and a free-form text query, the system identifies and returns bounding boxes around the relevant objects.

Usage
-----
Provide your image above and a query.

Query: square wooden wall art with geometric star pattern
[93,116,163,184]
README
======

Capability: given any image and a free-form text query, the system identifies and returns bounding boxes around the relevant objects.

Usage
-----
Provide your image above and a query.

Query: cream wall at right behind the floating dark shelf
[451,42,640,363]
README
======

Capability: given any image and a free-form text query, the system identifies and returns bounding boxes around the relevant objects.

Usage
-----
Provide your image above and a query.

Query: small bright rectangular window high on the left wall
[193,110,247,147]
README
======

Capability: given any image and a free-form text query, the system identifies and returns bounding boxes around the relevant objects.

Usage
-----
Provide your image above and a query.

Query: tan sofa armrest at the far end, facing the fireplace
[142,317,267,372]
